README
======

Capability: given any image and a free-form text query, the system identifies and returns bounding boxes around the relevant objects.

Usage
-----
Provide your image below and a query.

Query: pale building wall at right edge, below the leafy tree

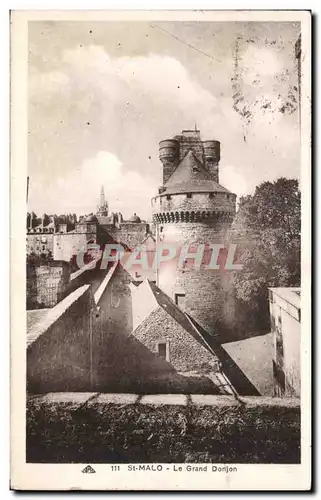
[269,288,301,397]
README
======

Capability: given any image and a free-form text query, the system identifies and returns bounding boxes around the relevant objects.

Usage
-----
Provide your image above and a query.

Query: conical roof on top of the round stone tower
[161,150,230,196]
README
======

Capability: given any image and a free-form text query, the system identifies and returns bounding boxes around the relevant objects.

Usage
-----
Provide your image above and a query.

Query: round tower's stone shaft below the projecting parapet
[158,222,234,334]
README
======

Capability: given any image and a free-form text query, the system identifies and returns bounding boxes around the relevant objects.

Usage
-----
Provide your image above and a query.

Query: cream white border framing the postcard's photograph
[10,11,311,491]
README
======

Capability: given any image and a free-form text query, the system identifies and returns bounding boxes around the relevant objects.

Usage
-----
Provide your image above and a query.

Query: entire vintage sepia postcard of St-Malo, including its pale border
[11,10,311,491]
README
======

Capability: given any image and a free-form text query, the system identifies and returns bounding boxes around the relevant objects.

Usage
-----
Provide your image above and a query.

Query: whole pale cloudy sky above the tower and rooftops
[28,21,300,218]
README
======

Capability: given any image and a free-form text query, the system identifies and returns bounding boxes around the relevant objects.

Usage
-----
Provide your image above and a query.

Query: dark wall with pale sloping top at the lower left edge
[27,285,94,393]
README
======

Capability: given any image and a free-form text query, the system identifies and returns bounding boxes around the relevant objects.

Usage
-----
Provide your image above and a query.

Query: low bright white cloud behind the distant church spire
[29,151,157,219]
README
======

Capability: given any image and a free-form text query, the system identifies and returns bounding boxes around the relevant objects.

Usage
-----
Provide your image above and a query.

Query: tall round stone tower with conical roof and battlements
[152,131,236,334]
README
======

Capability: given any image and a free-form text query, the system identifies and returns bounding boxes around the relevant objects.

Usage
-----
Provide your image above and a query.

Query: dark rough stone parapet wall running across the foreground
[26,393,300,464]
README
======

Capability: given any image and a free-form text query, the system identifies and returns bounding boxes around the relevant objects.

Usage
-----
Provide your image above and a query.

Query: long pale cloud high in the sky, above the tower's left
[63,45,216,108]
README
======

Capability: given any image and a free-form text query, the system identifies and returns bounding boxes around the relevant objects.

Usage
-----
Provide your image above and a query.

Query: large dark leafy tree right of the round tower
[230,178,301,329]
